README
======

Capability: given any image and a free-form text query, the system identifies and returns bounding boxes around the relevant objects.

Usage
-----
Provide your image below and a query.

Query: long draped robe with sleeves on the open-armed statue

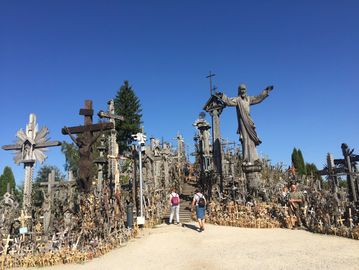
[222,90,268,164]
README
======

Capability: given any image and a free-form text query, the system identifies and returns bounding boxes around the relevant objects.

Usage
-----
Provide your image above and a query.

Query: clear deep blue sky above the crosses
[0,0,359,184]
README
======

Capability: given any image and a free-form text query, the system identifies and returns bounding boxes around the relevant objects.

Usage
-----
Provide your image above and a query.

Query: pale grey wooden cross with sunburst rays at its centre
[2,113,61,208]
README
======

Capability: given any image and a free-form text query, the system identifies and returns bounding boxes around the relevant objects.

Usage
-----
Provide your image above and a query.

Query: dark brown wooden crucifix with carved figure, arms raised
[62,100,114,193]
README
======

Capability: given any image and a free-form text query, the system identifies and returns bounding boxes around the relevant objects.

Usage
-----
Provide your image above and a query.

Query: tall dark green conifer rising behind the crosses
[114,81,142,153]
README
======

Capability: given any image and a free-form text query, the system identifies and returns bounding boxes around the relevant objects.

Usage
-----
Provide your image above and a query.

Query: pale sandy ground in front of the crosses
[31,223,359,270]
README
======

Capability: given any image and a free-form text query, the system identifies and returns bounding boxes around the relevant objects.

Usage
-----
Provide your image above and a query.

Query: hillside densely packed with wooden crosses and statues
[0,85,359,269]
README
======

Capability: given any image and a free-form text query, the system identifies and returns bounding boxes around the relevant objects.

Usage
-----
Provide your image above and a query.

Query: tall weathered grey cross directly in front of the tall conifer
[98,99,125,191]
